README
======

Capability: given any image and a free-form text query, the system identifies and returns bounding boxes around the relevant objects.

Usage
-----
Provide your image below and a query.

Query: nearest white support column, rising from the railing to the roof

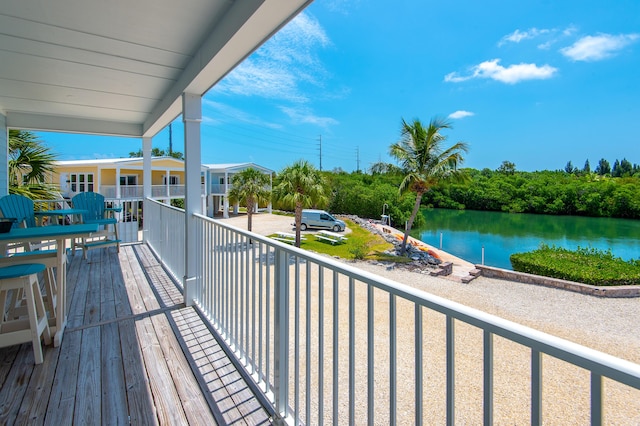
[182,93,202,306]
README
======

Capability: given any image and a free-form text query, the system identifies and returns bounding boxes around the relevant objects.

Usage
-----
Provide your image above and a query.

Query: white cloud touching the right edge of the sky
[560,34,640,61]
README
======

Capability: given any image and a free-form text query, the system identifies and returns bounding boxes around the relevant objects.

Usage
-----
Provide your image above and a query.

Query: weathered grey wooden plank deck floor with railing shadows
[0,241,270,425]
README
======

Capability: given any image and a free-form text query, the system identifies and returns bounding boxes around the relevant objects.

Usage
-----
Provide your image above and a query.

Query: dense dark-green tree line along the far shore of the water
[284,160,640,221]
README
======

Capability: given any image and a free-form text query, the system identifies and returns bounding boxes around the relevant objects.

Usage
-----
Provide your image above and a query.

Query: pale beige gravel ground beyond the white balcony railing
[216,213,640,425]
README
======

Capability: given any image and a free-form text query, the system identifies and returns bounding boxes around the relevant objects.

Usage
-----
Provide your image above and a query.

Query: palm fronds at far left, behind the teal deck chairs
[8,129,60,200]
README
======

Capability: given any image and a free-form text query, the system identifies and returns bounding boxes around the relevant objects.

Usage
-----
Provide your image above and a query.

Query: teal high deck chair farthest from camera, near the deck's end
[71,192,120,259]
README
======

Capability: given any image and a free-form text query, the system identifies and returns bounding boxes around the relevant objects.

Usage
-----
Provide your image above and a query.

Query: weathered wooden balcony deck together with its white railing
[0,202,640,424]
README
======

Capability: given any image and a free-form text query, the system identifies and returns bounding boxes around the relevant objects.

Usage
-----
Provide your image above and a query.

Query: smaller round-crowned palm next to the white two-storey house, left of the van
[229,167,271,231]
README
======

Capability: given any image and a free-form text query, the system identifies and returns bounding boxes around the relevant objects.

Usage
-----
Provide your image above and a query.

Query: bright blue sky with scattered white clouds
[40,0,640,171]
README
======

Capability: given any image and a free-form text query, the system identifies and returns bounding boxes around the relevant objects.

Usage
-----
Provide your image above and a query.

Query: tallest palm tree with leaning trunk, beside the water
[389,118,468,254]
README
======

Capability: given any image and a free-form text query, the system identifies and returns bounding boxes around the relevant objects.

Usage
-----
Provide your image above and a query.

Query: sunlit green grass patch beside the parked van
[270,219,409,262]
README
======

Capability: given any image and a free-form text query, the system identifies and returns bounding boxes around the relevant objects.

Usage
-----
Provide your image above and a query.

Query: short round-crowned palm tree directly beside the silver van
[273,160,329,247]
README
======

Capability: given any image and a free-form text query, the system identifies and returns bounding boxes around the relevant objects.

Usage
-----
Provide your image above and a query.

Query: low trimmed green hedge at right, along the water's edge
[510,244,640,286]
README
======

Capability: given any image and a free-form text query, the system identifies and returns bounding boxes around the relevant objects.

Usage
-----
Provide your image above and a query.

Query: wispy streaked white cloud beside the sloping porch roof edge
[214,12,331,103]
